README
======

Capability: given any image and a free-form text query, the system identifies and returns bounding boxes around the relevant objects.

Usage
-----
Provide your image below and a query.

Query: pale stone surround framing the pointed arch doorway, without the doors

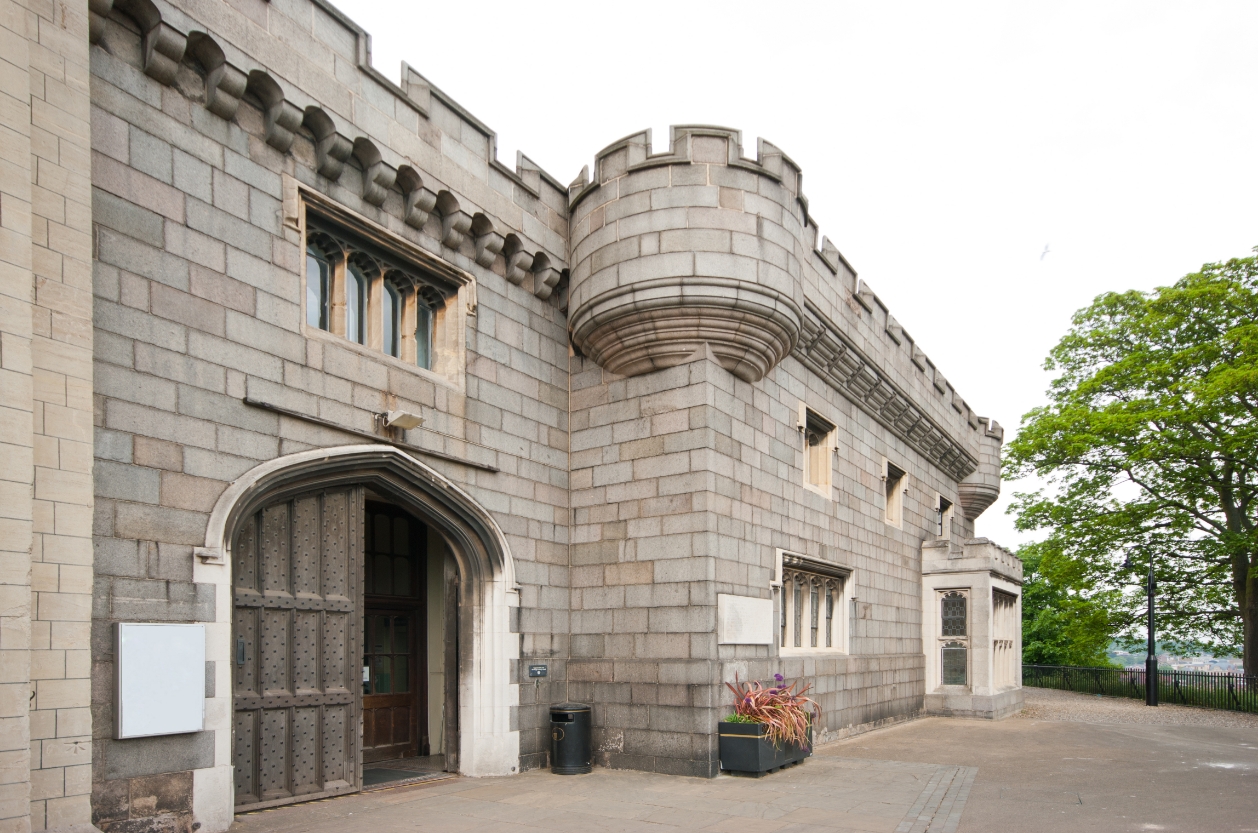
[192,444,520,833]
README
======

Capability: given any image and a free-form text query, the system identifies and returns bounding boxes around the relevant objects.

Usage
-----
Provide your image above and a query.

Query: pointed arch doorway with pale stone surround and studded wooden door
[194,445,520,815]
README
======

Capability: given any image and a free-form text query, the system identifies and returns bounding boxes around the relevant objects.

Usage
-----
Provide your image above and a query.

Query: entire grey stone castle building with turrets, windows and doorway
[0,0,1021,833]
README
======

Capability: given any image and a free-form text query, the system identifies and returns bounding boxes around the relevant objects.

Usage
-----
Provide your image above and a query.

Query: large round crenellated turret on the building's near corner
[569,126,811,381]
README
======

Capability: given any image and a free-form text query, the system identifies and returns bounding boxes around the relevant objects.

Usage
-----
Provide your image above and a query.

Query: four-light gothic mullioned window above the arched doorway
[306,209,457,370]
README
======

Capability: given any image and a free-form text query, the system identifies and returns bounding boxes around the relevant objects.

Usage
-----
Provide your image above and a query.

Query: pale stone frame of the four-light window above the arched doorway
[284,181,476,391]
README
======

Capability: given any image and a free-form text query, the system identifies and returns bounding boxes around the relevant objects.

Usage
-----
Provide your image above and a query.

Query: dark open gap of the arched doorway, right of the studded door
[362,503,458,789]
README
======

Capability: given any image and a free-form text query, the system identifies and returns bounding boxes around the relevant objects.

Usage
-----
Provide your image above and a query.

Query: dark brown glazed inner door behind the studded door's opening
[361,503,429,763]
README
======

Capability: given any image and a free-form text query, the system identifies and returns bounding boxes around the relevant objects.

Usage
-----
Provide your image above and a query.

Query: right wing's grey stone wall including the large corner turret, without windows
[570,126,999,775]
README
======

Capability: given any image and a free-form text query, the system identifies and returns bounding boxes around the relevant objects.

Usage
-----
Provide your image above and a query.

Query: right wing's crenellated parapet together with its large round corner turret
[569,125,999,483]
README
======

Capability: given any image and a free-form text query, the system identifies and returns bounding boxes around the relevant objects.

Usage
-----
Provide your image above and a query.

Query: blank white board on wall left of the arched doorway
[113,622,205,739]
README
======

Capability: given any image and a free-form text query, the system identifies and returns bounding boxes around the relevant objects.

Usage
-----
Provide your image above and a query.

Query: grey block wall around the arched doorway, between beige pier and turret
[84,0,567,830]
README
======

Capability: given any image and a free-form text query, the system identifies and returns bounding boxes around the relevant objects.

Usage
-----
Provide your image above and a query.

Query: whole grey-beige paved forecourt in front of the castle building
[231,690,1258,833]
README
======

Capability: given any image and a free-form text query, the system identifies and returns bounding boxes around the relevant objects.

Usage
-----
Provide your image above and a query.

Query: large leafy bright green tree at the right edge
[1005,249,1258,674]
